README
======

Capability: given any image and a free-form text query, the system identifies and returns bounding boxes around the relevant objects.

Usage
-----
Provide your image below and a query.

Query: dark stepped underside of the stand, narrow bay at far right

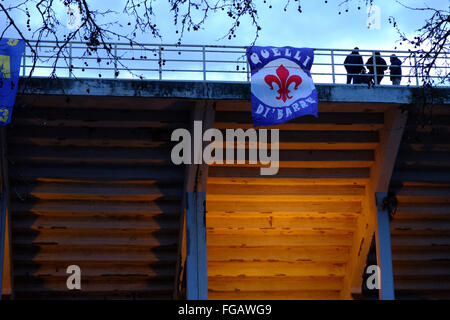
[390,111,450,299]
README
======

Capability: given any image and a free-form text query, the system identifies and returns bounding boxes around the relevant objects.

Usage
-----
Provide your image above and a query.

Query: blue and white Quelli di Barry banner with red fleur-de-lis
[247,46,318,126]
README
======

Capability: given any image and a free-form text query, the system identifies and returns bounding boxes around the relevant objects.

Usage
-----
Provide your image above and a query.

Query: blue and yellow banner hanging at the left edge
[0,38,25,126]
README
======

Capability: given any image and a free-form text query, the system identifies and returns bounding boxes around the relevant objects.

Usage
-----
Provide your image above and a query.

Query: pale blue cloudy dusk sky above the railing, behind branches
[0,0,450,82]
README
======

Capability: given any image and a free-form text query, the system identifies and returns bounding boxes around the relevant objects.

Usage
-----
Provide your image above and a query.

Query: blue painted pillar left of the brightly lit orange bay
[186,192,208,300]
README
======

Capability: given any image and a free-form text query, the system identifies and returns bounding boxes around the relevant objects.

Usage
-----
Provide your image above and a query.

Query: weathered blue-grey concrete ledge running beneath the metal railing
[19,77,450,104]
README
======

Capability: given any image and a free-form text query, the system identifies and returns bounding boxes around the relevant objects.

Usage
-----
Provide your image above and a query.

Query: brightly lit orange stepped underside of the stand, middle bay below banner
[206,101,387,299]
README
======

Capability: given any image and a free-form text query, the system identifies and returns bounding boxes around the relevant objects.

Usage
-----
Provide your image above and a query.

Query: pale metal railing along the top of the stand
[22,41,450,86]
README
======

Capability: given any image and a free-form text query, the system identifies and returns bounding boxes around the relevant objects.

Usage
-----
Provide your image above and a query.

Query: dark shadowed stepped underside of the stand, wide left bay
[8,96,192,299]
